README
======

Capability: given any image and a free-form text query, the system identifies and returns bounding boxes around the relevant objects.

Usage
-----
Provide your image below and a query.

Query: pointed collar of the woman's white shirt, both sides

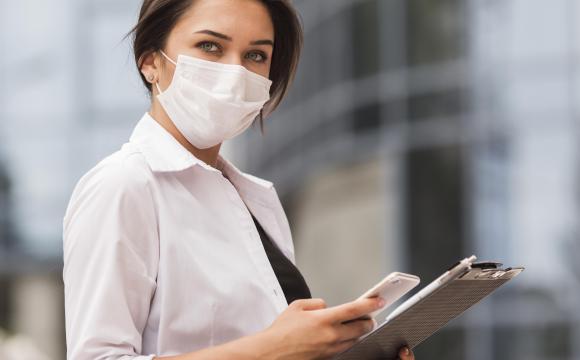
[129,112,273,196]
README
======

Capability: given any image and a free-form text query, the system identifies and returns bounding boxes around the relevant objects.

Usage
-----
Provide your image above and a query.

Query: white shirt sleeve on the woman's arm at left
[63,156,159,360]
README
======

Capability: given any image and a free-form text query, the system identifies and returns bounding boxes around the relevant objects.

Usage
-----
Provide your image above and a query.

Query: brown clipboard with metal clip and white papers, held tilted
[333,256,524,360]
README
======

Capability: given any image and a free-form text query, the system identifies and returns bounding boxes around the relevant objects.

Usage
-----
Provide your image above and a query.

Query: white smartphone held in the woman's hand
[357,272,421,318]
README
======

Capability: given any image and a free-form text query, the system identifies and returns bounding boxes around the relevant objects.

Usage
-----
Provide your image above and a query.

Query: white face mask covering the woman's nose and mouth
[155,51,272,149]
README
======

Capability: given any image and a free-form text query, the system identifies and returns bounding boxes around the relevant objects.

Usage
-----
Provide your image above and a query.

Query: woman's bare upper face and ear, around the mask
[154,0,274,89]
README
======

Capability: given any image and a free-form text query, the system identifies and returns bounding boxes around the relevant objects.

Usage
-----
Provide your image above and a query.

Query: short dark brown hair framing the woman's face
[125,0,303,130]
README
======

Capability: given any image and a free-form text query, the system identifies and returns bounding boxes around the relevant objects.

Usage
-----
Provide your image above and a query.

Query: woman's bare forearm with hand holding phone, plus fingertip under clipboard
[155,298,415,360]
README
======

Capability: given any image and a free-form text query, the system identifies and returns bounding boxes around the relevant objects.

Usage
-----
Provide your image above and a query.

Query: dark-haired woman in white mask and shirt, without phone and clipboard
[63,0,413,360]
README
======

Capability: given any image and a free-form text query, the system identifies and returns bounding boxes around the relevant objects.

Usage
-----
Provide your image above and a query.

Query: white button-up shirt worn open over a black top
[63,113,294,360]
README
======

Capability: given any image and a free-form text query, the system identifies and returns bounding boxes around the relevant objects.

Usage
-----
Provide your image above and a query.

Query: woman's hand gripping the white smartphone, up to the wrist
[265,298,386,360]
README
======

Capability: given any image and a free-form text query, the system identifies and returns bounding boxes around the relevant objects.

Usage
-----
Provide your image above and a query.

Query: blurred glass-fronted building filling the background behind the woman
[0,0,580,360]
